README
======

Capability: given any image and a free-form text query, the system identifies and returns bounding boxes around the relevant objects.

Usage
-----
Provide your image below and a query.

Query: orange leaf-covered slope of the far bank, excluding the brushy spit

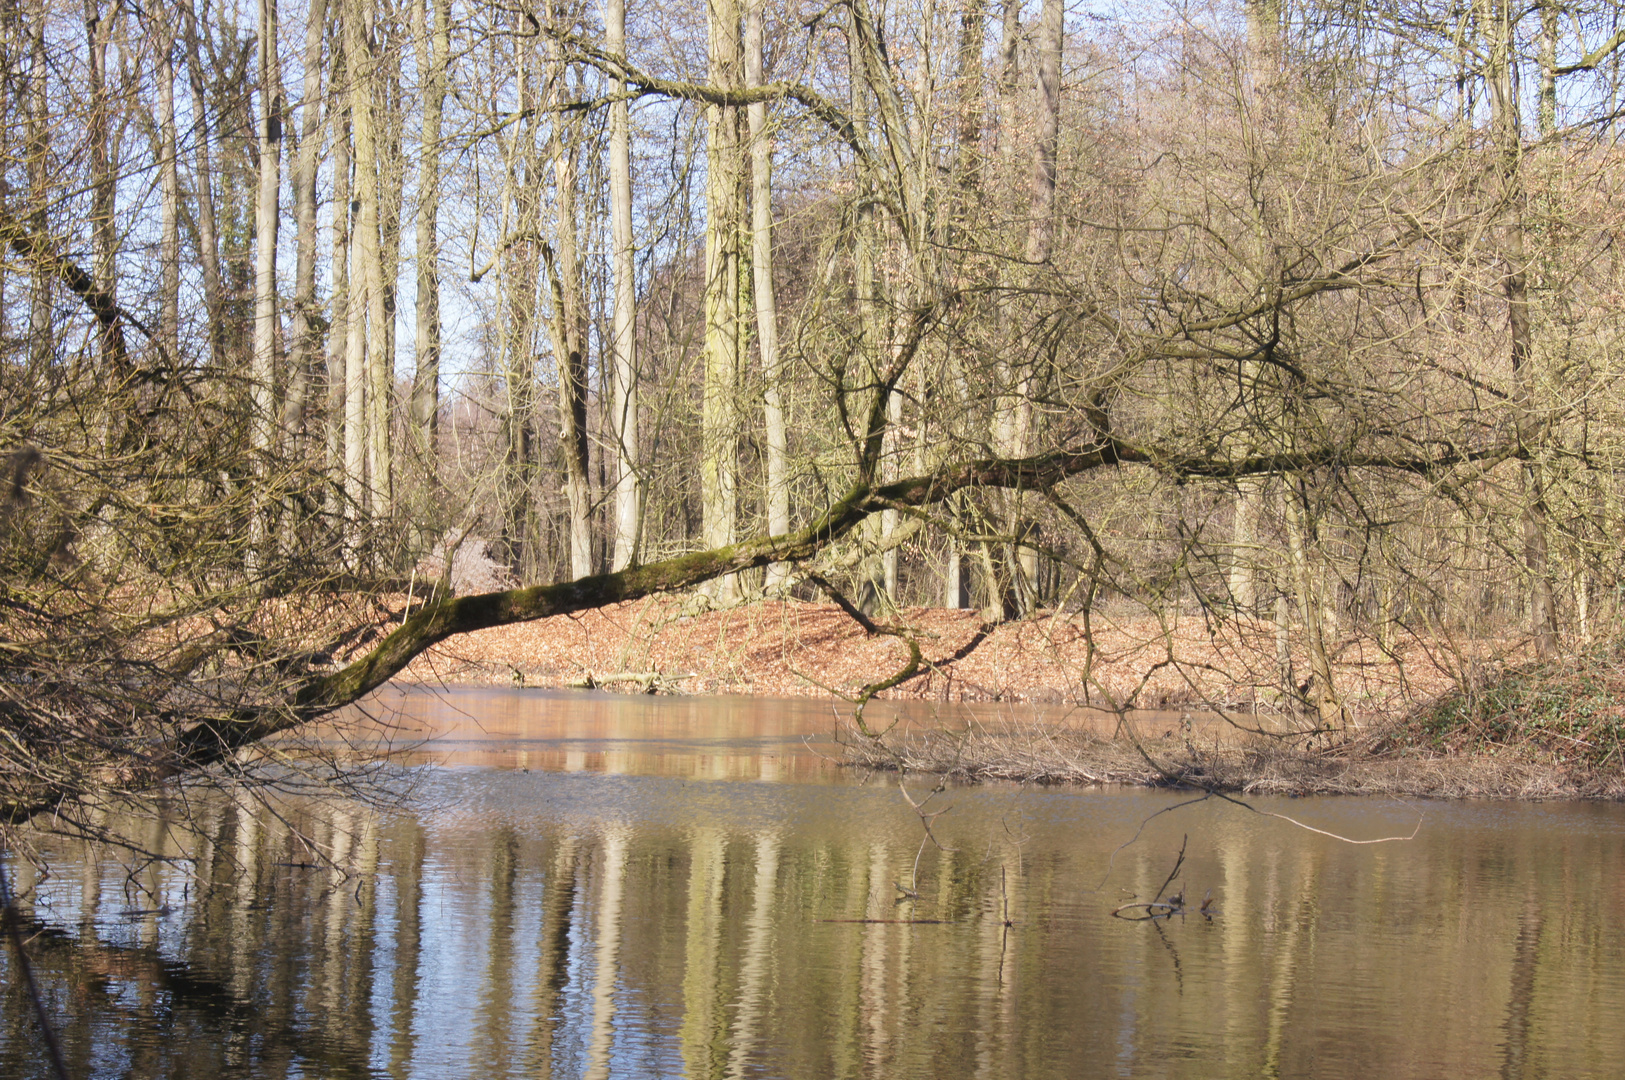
[405,599,1505,721]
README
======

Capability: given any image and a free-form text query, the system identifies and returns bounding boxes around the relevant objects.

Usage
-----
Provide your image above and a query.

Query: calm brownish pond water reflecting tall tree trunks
[0,690,1625,1080]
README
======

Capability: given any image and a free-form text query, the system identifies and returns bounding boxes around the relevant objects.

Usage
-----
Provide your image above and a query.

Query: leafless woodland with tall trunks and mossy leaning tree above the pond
[0,0,1625,823]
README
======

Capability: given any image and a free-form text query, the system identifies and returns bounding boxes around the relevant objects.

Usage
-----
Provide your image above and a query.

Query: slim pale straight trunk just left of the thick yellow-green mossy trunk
[605,0,643,570]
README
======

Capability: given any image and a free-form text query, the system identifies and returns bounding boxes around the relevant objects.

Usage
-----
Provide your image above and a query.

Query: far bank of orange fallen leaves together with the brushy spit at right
[405,599,1625,799]
